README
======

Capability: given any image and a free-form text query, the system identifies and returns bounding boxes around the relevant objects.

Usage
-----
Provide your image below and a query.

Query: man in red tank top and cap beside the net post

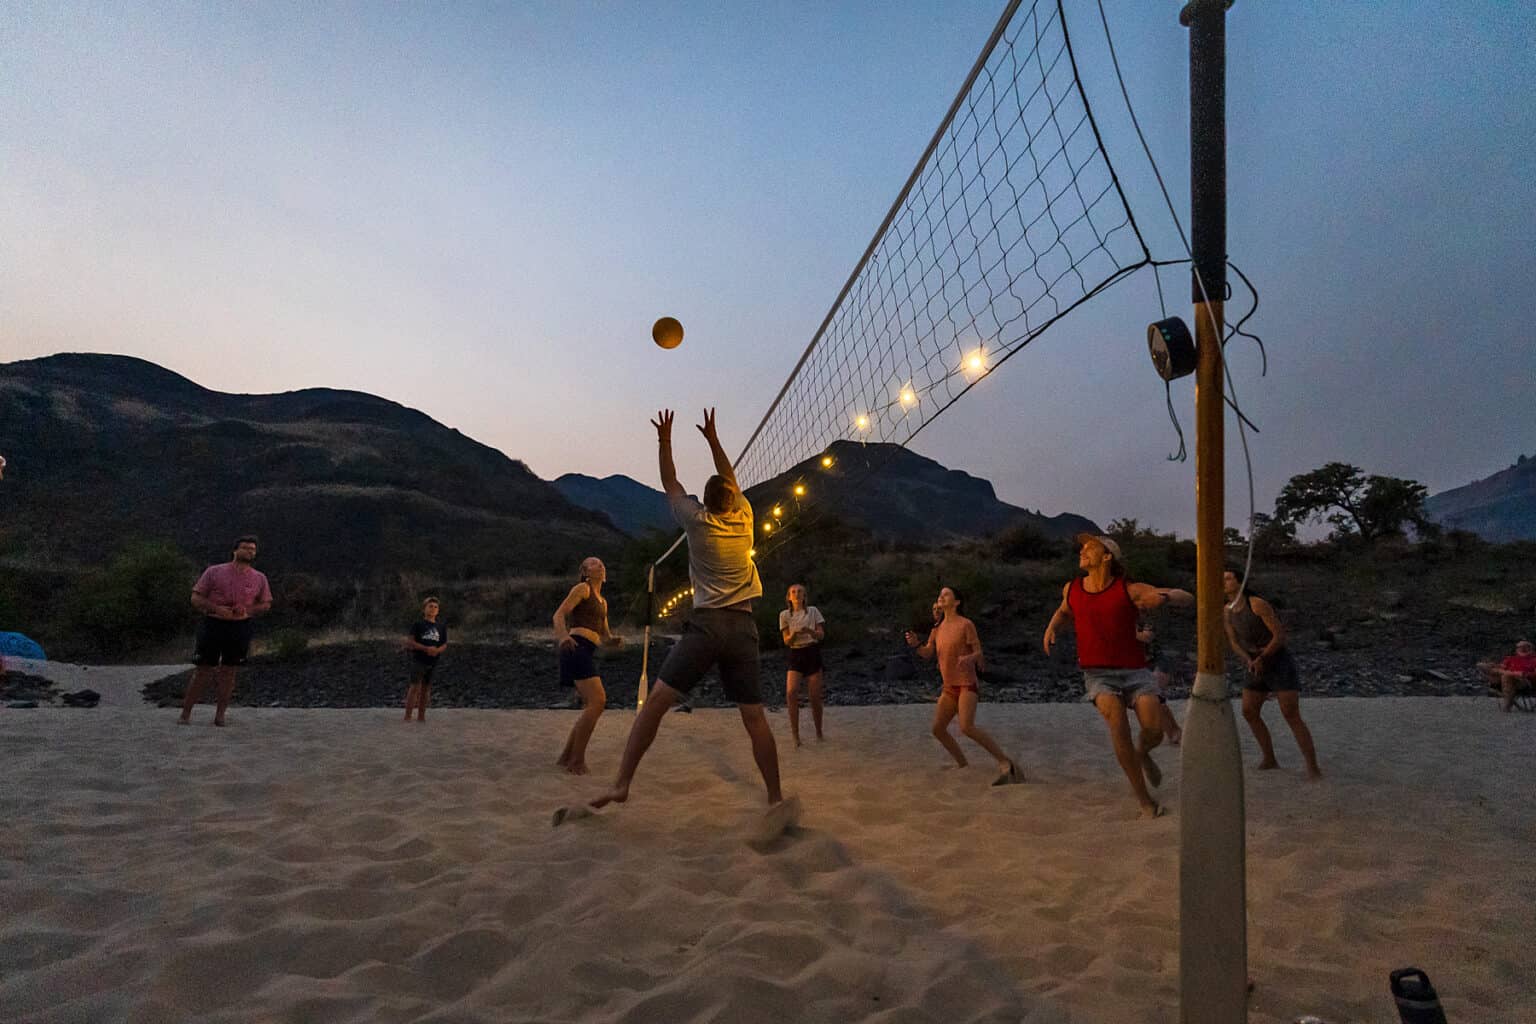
[1044,533,1195,818]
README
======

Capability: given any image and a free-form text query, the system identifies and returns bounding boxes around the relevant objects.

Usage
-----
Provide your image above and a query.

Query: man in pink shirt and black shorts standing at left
[180,536,272,725]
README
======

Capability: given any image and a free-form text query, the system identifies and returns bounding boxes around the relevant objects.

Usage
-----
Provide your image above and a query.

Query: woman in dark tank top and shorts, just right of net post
[1223,570,1322,778]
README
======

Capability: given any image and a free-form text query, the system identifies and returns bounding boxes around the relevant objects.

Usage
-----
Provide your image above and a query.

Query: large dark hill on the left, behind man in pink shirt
[0,355,622,580]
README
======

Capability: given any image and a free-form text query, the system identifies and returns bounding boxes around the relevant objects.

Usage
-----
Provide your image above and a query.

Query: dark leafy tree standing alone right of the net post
[1275,462,1432,542]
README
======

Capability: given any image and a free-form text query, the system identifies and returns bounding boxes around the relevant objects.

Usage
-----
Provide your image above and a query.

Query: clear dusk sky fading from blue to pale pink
[0,0,1536,536]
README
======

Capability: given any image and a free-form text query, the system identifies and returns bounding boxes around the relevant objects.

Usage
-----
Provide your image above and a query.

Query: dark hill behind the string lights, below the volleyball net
[748,441,1098,542]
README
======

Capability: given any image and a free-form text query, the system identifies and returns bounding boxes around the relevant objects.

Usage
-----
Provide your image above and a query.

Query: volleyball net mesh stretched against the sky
[736,0,1150,487]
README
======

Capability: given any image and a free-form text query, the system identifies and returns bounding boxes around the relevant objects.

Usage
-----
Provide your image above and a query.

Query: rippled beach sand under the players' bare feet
[0,681,1536,1024]
